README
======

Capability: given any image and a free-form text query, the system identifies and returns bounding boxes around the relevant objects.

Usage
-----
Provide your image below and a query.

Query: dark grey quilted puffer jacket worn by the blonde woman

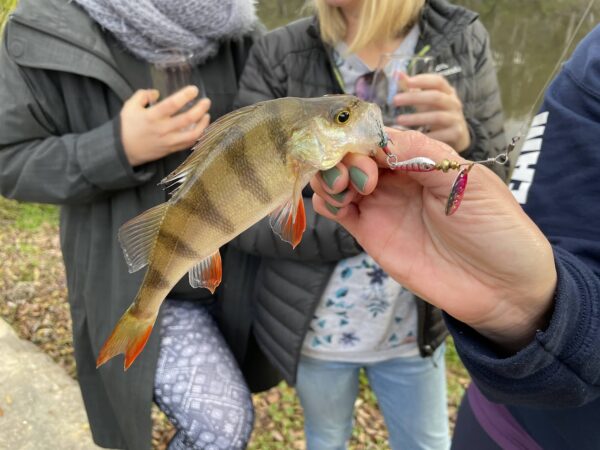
[224,0,506,383]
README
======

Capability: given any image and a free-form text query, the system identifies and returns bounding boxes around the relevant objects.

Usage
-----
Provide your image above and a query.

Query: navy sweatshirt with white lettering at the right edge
[446,27,600,407]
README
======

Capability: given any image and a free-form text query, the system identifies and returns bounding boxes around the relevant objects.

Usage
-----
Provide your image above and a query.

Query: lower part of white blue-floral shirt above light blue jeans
[302,253,419,363]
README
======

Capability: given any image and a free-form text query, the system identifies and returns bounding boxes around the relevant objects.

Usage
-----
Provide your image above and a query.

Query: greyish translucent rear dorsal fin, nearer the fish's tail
[119,203,169,273]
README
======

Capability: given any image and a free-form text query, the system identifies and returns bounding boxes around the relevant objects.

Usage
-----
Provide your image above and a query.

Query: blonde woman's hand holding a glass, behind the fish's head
[394,72,471,153]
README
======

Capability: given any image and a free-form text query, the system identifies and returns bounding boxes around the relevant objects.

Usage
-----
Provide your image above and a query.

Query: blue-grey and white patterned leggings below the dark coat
[154,300,254,450]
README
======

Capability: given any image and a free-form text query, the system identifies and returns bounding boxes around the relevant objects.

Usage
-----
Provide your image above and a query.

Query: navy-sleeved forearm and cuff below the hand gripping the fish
[446,249,600,407]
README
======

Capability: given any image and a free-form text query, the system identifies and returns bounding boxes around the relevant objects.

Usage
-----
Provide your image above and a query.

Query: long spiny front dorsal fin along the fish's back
[160,103,261,196]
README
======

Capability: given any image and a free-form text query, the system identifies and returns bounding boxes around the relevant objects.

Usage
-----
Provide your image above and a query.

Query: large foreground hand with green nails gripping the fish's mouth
[311,130,557,350]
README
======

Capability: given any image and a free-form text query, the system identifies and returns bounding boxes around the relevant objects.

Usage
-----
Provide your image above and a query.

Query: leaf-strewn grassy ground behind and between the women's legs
[0,197,468,450]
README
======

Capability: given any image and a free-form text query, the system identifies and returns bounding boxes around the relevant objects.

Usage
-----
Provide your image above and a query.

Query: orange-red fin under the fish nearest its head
[269,169,306,248]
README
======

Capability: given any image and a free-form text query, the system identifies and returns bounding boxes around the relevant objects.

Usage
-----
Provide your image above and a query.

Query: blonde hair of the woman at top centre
[313,0,425,52]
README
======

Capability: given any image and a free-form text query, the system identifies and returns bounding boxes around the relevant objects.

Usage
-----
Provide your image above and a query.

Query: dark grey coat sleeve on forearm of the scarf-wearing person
[0,119,154,204]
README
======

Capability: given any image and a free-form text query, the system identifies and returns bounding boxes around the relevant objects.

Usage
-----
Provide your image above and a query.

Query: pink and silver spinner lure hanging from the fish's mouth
[381,136,520,216]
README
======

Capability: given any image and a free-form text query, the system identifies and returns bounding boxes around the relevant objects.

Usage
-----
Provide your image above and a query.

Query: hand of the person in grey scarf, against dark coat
[121,86,210,167]
